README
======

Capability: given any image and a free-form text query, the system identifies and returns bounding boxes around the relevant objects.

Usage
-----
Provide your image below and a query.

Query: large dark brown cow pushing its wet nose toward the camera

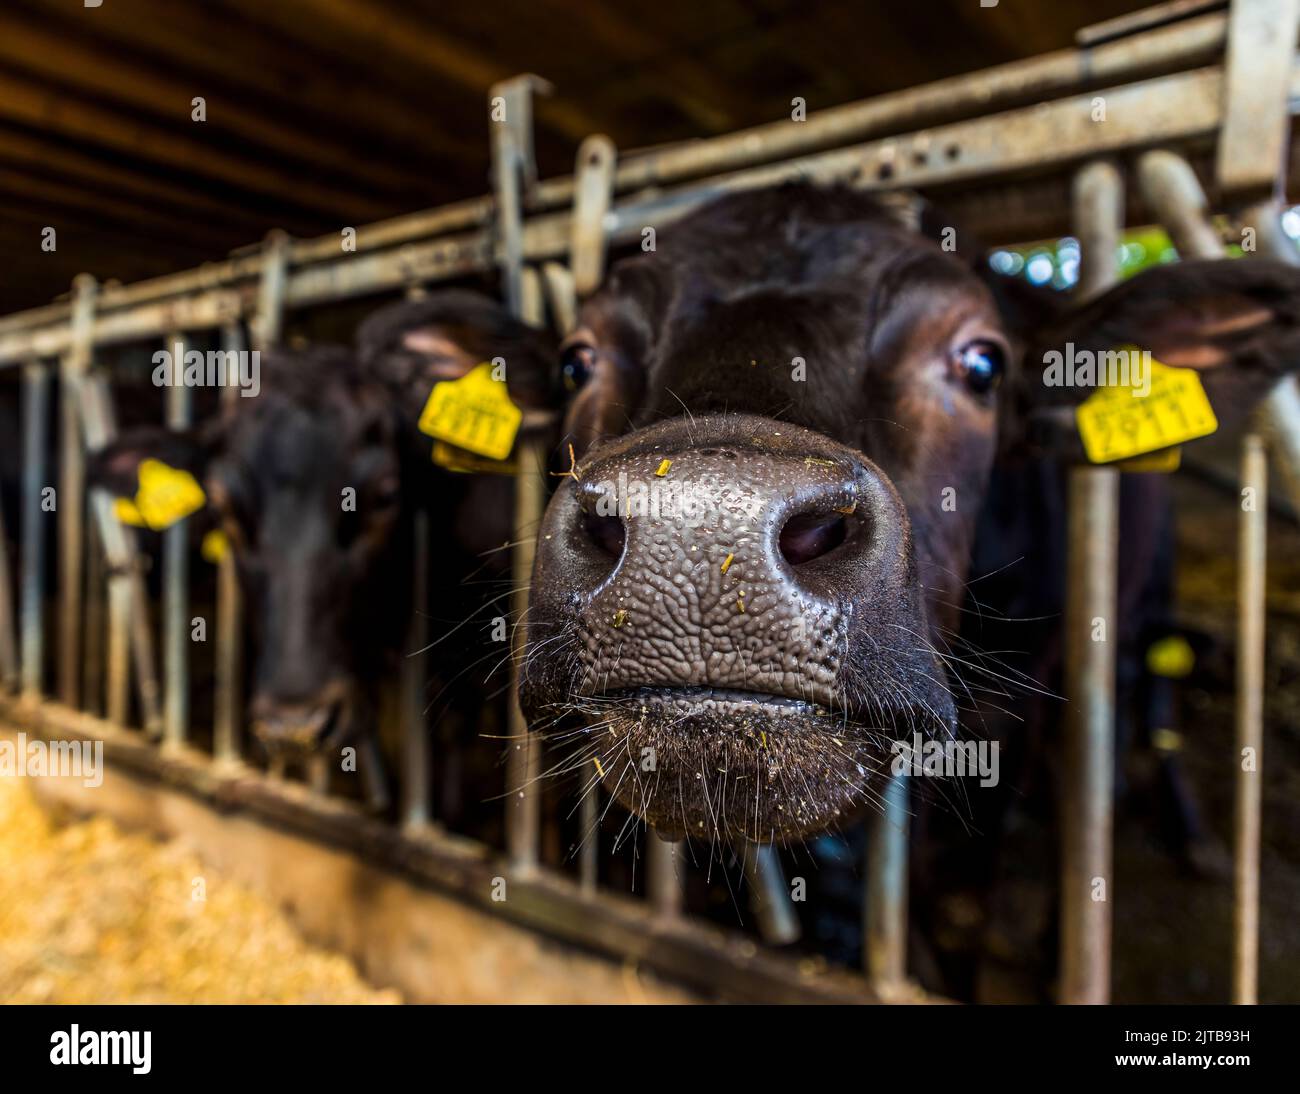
[486,183,1300,862]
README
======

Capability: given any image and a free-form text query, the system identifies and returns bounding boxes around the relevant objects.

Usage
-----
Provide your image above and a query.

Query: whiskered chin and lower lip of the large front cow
[584,687,896,845]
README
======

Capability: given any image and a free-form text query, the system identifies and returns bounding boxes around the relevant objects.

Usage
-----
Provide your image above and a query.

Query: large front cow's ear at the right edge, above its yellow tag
[1000,259,1300,455]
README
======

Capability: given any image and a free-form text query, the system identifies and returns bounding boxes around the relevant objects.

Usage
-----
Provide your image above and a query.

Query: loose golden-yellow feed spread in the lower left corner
[0,763,402,1003]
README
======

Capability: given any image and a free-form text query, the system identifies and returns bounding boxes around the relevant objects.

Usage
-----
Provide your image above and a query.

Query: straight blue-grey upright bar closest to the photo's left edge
[20,361,49,699]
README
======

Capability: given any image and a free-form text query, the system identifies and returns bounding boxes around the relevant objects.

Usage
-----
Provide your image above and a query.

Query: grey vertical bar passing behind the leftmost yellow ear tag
[163,331,192,748]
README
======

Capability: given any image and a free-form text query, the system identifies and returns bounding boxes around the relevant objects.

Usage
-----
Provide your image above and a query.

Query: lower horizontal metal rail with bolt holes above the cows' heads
[10,53,1300,365]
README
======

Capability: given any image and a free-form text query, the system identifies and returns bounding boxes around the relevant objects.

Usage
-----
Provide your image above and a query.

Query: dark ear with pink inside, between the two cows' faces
[356,290,556,416]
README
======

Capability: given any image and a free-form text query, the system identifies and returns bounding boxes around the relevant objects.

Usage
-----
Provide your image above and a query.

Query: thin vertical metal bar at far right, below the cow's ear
[1232,433,1269,1003]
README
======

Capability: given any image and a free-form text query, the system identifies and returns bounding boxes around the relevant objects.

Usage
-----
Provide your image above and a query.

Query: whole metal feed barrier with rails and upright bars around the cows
[0,0,1300,1003]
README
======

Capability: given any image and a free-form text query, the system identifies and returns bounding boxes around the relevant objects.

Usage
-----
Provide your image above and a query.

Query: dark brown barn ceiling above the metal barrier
[0,0,1159,313]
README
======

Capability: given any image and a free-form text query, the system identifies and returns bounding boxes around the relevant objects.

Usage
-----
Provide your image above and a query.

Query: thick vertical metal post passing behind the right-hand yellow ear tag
[1060,162,1125,1003]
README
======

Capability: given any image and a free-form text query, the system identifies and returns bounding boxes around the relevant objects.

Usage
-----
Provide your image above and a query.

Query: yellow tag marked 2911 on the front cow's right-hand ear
[1074,347,1218,464]
